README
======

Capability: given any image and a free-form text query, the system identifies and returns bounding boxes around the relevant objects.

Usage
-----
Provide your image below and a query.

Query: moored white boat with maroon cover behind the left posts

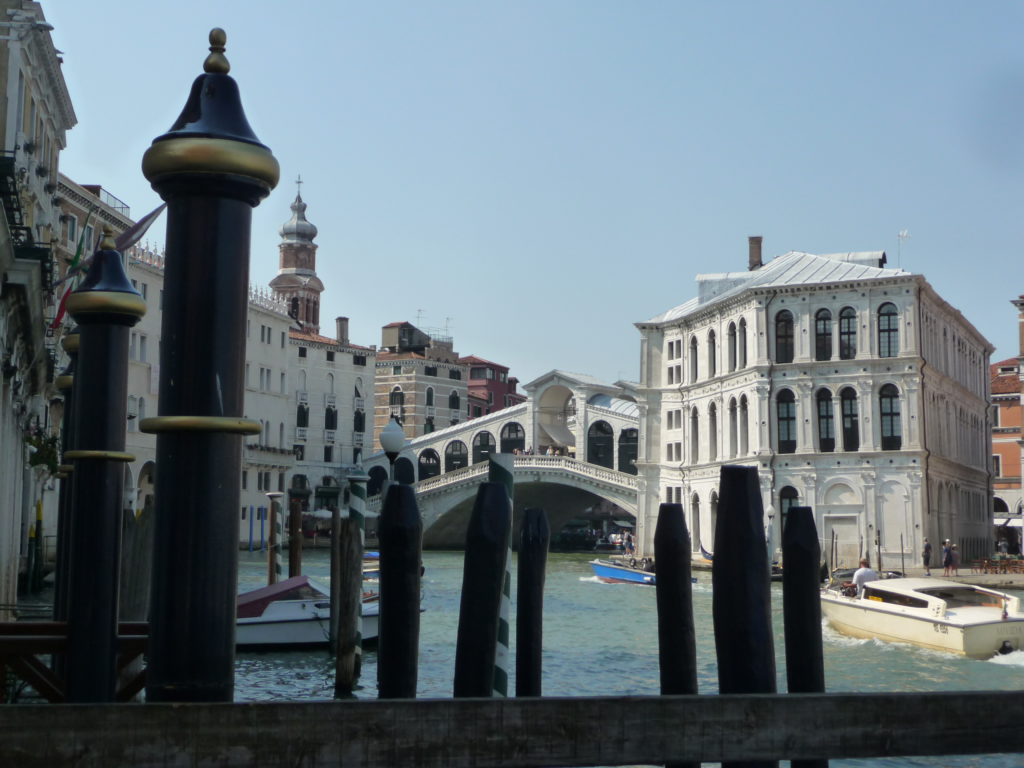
[234,575,380,649]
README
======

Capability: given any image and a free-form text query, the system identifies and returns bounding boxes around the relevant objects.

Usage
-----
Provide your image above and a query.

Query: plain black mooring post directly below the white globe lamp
[377,483,423,698]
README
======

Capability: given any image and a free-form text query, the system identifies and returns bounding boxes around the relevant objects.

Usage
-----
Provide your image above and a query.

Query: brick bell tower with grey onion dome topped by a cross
[270,177,324,334]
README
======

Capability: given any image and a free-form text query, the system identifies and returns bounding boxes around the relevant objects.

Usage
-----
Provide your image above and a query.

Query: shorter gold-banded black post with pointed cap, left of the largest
[65,227,145,703]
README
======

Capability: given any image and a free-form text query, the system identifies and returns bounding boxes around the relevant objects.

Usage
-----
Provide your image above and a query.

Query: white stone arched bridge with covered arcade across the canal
[362,371,639,548]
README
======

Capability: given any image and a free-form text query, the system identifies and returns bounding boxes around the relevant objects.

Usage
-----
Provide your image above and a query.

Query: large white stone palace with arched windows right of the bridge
[637,238,992,568]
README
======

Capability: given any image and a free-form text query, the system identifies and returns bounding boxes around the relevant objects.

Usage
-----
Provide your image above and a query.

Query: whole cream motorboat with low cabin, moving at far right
[821,579,1024,658]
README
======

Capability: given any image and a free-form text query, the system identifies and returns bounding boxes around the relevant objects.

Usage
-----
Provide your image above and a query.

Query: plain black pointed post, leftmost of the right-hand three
[654,504,699,768]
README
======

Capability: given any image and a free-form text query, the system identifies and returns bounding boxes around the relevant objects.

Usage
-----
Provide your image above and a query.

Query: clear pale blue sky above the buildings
[43,0,1024,382]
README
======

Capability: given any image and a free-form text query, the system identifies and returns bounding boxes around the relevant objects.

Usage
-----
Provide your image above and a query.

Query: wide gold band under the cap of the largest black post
[142,136,281,188]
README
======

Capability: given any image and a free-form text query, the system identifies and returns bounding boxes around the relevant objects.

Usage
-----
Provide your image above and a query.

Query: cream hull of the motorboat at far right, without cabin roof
[821,580,1024,658]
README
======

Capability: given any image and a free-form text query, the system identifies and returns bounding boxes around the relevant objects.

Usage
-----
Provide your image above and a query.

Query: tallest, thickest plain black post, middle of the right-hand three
[712,466,778,768]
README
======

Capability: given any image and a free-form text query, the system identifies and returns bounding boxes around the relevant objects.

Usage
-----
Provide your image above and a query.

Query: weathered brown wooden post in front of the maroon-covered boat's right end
[331,515,362,698]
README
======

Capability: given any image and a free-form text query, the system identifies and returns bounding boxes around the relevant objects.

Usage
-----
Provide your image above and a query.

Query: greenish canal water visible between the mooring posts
[236,550,1024,768]
